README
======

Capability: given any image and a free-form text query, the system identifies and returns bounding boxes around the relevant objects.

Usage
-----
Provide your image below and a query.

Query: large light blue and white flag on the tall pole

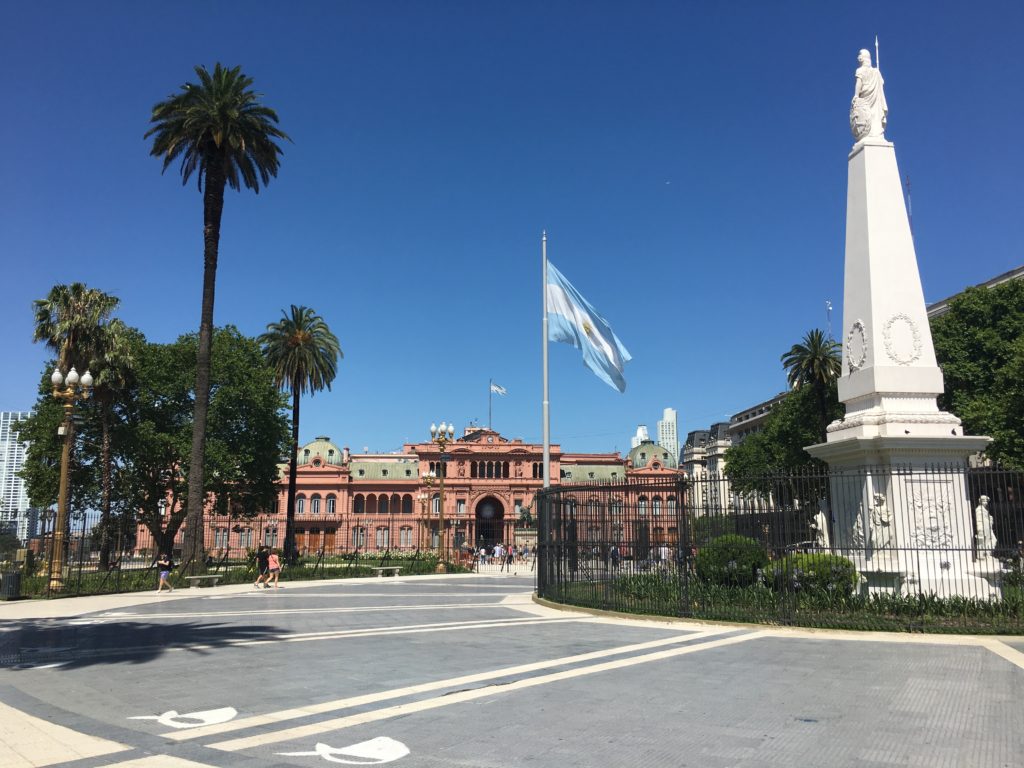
[545,261,632,392]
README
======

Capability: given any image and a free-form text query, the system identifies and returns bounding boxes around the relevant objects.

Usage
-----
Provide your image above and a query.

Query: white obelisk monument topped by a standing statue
[807,49,991,597]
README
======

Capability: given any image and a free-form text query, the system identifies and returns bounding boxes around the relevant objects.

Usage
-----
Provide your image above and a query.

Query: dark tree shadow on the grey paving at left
[0,620,282,669]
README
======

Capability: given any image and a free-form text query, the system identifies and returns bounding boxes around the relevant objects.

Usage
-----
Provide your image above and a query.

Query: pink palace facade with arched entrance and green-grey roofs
[136,428,678,556]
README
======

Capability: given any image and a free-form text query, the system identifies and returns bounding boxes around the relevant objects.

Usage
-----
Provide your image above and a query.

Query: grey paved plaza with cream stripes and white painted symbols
[0,570,1024,768]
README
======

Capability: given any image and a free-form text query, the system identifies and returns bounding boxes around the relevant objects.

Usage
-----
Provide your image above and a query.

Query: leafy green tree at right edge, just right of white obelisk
[931,280,1024,468]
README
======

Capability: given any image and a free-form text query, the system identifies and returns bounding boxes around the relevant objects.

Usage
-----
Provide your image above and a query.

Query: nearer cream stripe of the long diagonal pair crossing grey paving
[209,632,764,752]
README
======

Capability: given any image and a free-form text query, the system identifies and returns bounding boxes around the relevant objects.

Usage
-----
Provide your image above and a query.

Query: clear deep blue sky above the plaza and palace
[0,0,1024,452]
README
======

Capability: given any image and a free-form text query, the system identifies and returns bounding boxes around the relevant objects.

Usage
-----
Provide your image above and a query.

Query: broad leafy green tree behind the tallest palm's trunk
[121,327,288,552]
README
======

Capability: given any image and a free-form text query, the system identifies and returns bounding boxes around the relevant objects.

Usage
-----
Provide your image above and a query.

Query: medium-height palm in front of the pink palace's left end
[259,304,344,562]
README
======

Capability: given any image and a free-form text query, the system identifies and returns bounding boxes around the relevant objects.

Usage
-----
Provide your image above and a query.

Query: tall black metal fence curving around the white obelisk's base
[538,466,1024,633]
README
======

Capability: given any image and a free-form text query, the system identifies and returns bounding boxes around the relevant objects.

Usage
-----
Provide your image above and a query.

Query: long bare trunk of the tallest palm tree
[181,159,225,573]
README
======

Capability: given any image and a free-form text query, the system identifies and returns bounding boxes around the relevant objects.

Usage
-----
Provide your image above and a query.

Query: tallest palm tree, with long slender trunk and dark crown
[145,63,288,570]
